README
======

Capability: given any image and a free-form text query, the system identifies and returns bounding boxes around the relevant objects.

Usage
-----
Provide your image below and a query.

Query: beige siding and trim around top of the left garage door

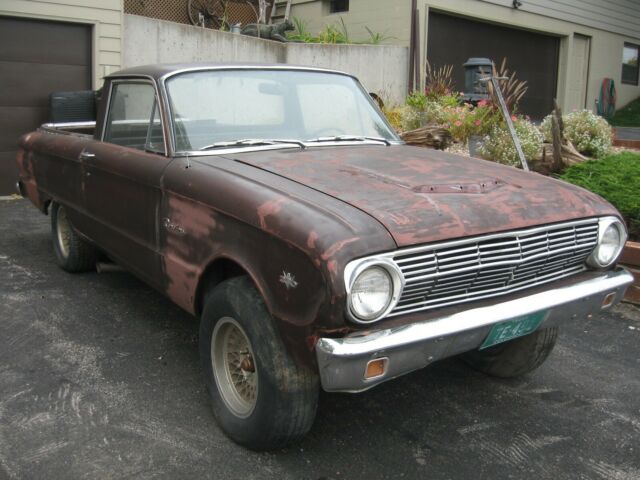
[0,0,122,88]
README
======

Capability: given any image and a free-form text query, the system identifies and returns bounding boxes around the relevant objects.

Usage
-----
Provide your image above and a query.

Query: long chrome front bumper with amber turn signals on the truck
[316,268,633,392]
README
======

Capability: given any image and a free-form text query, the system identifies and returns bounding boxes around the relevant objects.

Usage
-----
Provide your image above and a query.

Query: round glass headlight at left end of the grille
[350,266,393,320]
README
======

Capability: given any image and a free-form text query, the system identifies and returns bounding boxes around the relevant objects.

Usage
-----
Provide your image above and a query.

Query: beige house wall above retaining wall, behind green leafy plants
[291,0,411,46]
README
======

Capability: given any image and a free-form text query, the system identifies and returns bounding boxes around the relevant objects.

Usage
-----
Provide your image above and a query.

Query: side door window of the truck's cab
[104,82,165,154]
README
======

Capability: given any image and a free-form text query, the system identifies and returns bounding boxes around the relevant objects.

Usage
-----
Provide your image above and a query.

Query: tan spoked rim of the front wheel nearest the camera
[211,317,258,418]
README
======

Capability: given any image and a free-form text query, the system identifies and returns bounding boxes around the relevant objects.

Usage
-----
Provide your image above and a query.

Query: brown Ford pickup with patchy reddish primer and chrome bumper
[17,65,632,449]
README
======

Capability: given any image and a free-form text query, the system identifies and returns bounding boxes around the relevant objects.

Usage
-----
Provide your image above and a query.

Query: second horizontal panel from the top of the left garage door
[0,62,91,107]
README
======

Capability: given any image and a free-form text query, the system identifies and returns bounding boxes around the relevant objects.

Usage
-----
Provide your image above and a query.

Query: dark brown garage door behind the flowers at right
[427,12,560,119]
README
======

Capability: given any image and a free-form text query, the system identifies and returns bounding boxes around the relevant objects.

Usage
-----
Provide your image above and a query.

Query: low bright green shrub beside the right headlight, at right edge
[560,152,640,240]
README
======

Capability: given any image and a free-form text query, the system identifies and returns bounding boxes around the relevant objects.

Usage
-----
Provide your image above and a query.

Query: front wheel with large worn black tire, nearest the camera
[200,276,319,450]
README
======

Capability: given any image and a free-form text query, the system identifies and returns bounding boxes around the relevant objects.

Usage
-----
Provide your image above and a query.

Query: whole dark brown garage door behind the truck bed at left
[0,17,92,195]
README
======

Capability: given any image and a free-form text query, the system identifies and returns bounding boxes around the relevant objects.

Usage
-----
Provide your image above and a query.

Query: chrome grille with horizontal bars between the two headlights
[389,219,598,316]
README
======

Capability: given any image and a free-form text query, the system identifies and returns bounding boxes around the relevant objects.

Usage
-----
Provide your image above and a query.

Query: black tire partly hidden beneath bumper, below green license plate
[461,327,558,378]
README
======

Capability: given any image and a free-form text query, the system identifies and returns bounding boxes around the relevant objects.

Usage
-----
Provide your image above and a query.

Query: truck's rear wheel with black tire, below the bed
[50,202,98,273]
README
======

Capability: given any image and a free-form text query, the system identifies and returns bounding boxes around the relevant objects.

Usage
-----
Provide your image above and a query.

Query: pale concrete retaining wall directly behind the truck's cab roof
[122,14,409,104]
